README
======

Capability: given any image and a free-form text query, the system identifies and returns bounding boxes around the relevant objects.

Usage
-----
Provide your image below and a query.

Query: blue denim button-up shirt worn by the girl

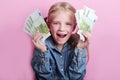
[32,36,86,80]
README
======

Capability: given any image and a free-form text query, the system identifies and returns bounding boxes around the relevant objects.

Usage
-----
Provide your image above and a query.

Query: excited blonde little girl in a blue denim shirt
[32,2,88,80]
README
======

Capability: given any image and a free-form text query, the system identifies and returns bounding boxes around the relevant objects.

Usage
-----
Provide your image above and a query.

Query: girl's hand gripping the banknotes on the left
[32,32,47,52]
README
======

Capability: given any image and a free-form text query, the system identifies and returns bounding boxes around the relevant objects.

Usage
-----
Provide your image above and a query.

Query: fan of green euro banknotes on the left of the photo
[24,9,50,43]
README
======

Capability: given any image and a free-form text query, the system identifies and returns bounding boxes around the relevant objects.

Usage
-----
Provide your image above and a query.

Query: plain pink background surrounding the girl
[0,0,120,80]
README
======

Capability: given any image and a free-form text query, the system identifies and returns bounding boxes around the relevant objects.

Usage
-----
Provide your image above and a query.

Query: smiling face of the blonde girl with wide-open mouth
[50,10,75,46]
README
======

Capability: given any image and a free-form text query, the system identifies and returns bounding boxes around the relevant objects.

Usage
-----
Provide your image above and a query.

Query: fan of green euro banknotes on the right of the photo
[75,6,98,41]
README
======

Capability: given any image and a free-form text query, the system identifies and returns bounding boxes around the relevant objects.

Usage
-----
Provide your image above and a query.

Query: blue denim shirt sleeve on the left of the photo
[31,48,52,79]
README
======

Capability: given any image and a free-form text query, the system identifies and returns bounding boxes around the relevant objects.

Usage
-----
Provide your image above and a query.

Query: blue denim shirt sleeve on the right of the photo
[68,48,86,80]
